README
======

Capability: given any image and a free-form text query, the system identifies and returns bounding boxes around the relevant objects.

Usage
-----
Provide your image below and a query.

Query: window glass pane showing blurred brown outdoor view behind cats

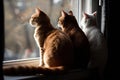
[4,0,77,61]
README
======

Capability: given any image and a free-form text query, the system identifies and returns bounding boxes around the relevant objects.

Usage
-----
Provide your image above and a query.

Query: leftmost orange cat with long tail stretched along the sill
[3,8,73,75]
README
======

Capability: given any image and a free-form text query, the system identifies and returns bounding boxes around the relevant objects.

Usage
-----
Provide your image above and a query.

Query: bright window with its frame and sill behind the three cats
[3,0,98,79]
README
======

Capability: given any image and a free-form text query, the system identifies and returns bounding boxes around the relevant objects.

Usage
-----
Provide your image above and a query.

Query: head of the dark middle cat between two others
[58,10,77,29]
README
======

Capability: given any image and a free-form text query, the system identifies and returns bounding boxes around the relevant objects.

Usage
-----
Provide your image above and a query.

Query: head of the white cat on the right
[80,11,97,27]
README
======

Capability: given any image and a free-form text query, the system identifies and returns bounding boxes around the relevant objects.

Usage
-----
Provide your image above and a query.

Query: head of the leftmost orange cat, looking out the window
[29,8,50,27]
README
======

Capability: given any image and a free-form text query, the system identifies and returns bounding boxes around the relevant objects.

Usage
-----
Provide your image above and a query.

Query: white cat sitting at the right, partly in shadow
[80,12,108,80]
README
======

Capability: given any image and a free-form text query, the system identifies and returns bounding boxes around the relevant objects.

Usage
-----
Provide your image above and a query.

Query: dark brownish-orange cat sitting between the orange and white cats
[58,11,90,68]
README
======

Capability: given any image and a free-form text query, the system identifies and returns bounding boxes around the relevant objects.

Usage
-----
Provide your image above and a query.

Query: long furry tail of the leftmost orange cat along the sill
[3,66,66,76]
